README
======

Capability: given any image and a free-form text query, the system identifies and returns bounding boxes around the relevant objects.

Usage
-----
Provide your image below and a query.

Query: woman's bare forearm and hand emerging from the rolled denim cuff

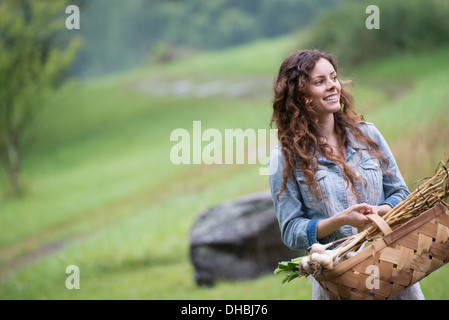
[316,203,378,240]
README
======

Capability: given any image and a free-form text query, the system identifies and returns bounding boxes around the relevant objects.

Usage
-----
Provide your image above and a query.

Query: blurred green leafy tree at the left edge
[0,0,81,195]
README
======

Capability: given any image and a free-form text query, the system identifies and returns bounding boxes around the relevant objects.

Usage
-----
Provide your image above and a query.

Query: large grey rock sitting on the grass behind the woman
[190,191,302,285]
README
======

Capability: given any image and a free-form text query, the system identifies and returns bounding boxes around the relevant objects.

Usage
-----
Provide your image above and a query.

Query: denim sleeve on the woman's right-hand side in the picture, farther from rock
[362,123,410,208]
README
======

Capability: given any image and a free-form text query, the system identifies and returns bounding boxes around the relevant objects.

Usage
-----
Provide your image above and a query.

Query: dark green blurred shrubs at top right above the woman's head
[306,0,449,66]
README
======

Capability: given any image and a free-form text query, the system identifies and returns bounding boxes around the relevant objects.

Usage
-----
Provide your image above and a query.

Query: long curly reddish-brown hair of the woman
[270,49,388,200]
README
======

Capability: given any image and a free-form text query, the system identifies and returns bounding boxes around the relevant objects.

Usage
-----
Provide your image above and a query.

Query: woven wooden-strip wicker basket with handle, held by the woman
[315,204,449,300]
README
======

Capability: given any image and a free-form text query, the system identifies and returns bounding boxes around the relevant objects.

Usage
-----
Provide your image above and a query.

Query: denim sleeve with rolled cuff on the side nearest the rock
[268,147,320,250]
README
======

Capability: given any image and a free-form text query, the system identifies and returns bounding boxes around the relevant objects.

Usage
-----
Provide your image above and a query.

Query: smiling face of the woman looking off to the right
[309,58,341,118]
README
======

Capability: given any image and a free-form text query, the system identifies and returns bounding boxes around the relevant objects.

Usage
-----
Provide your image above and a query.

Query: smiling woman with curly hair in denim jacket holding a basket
[269,50,424,299]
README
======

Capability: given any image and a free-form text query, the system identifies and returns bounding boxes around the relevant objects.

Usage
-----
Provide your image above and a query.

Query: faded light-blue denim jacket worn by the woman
[268,123,410,250]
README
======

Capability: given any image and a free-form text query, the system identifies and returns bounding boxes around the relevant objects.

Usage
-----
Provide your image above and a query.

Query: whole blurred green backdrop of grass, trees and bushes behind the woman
[0,0,449,299]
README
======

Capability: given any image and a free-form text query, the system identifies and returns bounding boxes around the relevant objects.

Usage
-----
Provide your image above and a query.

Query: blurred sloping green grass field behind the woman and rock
[0,36,449,299]
